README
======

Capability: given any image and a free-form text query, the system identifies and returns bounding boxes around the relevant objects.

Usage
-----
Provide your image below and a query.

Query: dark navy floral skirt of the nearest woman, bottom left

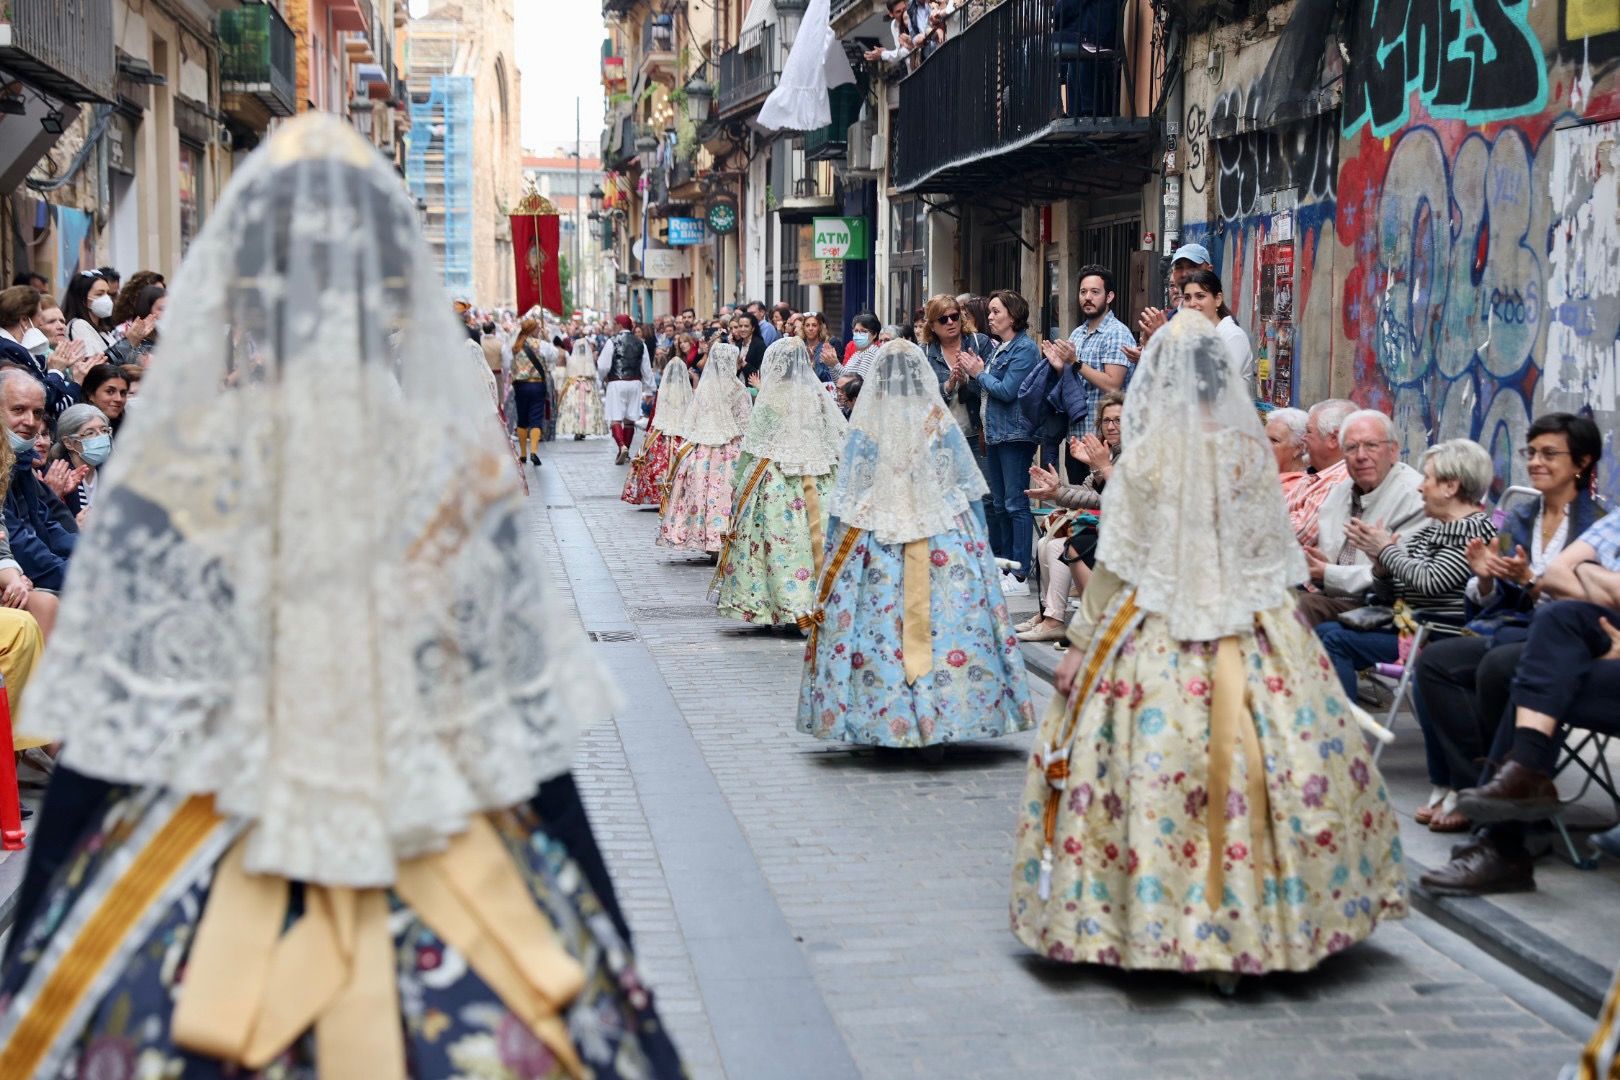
[0,795,684,1080]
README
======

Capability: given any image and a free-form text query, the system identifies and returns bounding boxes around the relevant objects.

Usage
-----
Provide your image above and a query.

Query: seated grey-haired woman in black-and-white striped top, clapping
[1317,439,1497,698]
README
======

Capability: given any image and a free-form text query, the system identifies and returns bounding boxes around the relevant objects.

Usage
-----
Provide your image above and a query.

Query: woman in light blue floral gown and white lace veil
[799,342,1035,746]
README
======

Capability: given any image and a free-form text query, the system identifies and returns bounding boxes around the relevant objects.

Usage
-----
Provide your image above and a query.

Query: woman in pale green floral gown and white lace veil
[714,337,849,627]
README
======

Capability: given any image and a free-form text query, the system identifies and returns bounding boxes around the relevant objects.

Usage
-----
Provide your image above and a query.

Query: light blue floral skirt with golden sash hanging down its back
[799,512,1035,746]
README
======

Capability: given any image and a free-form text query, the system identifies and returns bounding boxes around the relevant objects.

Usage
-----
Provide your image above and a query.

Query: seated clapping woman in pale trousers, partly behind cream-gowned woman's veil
[1016,390,1124,641]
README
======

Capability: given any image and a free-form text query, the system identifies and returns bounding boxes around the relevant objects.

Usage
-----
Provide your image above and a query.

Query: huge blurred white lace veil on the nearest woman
[28,113,606,887]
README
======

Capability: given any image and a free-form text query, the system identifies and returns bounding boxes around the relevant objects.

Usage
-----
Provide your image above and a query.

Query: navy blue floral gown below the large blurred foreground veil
[0,797,685,1080]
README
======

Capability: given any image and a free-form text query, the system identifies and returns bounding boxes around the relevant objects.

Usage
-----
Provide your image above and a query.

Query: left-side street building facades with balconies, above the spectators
[0,0,405,291]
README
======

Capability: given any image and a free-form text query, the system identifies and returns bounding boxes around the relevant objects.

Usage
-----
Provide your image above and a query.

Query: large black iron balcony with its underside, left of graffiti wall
[894,0,1163,202]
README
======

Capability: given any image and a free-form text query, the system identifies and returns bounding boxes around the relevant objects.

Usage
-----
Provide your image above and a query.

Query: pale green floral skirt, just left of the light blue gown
[716,455,838,625]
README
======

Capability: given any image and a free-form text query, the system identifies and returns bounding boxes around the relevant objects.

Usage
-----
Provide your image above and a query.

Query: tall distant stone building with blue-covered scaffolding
[400,0,523,306]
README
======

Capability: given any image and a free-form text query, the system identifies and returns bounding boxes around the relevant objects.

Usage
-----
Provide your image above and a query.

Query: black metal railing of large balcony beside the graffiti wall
[894,0,1145,189]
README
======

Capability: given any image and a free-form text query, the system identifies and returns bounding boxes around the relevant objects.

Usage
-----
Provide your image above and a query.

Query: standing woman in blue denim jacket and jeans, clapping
[959,288,1042,596]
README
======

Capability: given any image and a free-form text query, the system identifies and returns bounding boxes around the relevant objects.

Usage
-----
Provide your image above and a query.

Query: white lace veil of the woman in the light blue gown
[829,340,990,544]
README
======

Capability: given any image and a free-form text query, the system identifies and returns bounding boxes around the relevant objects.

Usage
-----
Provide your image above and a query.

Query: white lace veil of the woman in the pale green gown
[742,337,849,476]
